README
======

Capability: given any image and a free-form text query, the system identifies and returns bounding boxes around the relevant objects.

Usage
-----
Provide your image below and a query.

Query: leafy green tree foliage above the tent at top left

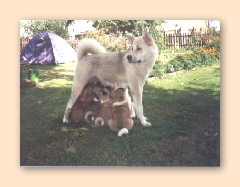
[22,20,73,39]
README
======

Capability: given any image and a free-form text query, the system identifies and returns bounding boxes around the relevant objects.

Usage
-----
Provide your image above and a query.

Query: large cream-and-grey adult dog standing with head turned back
[63,32,158,126]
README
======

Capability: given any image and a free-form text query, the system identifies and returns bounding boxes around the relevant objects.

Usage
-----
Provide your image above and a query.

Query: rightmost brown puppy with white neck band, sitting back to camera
[108,88,133,136]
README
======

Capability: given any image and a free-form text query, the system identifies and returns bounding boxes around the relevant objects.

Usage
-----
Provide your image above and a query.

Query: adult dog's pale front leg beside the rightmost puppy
[130,86,151,127]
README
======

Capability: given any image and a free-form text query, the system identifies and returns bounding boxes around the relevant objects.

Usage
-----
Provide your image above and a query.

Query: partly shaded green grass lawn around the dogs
[20,63,220,166]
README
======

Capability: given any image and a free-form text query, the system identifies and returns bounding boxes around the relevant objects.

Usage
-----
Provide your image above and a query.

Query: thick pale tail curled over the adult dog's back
[77,38,106,60]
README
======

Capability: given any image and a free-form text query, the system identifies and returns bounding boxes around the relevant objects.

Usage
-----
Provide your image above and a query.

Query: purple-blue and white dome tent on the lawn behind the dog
[20,32,77,64]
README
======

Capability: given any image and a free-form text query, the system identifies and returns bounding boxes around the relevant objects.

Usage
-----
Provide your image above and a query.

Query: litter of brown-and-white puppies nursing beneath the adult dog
[65,76,135,136]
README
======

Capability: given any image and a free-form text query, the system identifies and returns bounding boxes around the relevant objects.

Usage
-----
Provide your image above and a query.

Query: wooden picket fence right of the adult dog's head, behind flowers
[164,33,209,48]
